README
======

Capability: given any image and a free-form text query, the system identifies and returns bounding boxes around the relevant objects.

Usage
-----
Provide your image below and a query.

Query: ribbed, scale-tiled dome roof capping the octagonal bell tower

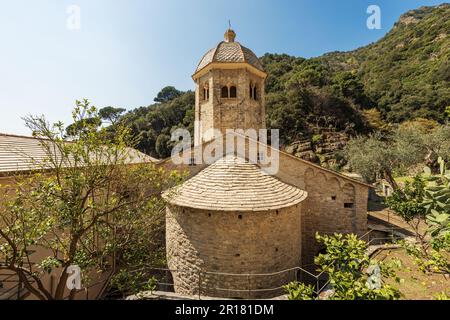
[195,41,264,73]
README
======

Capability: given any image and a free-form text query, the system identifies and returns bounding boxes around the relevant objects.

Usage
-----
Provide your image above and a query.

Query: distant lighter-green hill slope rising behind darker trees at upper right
[322,4,450,122]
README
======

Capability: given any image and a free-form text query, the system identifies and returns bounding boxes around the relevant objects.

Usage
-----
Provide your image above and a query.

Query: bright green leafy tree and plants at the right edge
[386,158,450,273]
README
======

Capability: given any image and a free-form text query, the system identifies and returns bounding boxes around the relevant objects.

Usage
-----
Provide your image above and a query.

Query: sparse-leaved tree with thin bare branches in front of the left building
[0,100,179,300]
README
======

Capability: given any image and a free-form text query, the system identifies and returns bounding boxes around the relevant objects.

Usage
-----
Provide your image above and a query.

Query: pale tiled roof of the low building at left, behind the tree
[0,133,157,175]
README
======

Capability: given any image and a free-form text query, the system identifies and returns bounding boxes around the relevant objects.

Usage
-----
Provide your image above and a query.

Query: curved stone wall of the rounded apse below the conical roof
[166,204,301,298]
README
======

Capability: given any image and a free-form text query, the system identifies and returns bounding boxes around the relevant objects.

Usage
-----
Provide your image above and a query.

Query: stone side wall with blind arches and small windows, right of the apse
[268,153,369,270]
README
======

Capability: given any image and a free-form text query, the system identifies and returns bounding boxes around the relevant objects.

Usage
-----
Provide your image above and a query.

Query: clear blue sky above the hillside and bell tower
[0,0,445,134]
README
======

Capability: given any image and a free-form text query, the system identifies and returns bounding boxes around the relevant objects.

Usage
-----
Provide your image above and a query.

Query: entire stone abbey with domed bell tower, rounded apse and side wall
[162,29,370,298]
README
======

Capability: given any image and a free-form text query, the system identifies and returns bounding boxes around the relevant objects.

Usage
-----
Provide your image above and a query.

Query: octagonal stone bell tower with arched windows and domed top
[192,28,267,146]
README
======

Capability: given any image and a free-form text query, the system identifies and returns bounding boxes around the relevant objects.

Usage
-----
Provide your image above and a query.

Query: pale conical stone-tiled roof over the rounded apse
[164,155,307,211]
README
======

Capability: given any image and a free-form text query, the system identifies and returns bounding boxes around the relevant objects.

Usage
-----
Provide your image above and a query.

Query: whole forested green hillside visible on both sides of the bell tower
[115,4,450,161]
